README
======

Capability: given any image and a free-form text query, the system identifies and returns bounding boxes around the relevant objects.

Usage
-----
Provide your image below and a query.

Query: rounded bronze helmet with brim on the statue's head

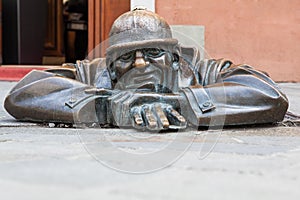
[106,8,178,55]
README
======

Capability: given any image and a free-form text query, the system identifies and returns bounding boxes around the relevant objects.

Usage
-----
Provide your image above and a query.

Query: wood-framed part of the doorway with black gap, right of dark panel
[44,0,130,64]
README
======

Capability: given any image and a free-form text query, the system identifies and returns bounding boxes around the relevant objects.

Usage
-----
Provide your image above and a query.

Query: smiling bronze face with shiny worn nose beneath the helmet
[110,48,178,92]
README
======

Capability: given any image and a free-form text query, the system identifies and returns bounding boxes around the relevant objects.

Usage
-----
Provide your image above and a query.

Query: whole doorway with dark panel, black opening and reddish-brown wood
[0,0,130,65]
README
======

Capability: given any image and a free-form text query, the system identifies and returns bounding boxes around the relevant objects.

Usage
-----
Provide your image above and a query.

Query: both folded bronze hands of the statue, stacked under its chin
[110,91,187,131]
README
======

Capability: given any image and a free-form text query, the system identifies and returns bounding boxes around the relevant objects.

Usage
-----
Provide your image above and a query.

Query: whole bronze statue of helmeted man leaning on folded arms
[5,9,288,131]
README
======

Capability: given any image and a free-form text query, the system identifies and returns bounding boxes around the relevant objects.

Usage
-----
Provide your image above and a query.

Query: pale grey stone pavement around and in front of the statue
[0,82,300,200]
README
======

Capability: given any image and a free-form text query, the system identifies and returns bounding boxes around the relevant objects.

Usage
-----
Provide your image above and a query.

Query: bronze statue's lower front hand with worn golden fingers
[130,103,187,131]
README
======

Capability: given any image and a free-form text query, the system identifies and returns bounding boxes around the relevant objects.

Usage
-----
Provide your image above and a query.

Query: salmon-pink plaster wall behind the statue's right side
[156,0,300,82]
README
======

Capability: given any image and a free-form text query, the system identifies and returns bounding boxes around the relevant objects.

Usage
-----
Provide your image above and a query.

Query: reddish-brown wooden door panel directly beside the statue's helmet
[88,0,130,57]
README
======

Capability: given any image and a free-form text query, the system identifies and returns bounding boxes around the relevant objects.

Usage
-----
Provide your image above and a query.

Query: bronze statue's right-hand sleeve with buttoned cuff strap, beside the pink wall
[182,59,288,126]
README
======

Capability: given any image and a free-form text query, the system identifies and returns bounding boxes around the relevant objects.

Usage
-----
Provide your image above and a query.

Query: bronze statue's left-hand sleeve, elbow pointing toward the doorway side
[4,70,111,123]
